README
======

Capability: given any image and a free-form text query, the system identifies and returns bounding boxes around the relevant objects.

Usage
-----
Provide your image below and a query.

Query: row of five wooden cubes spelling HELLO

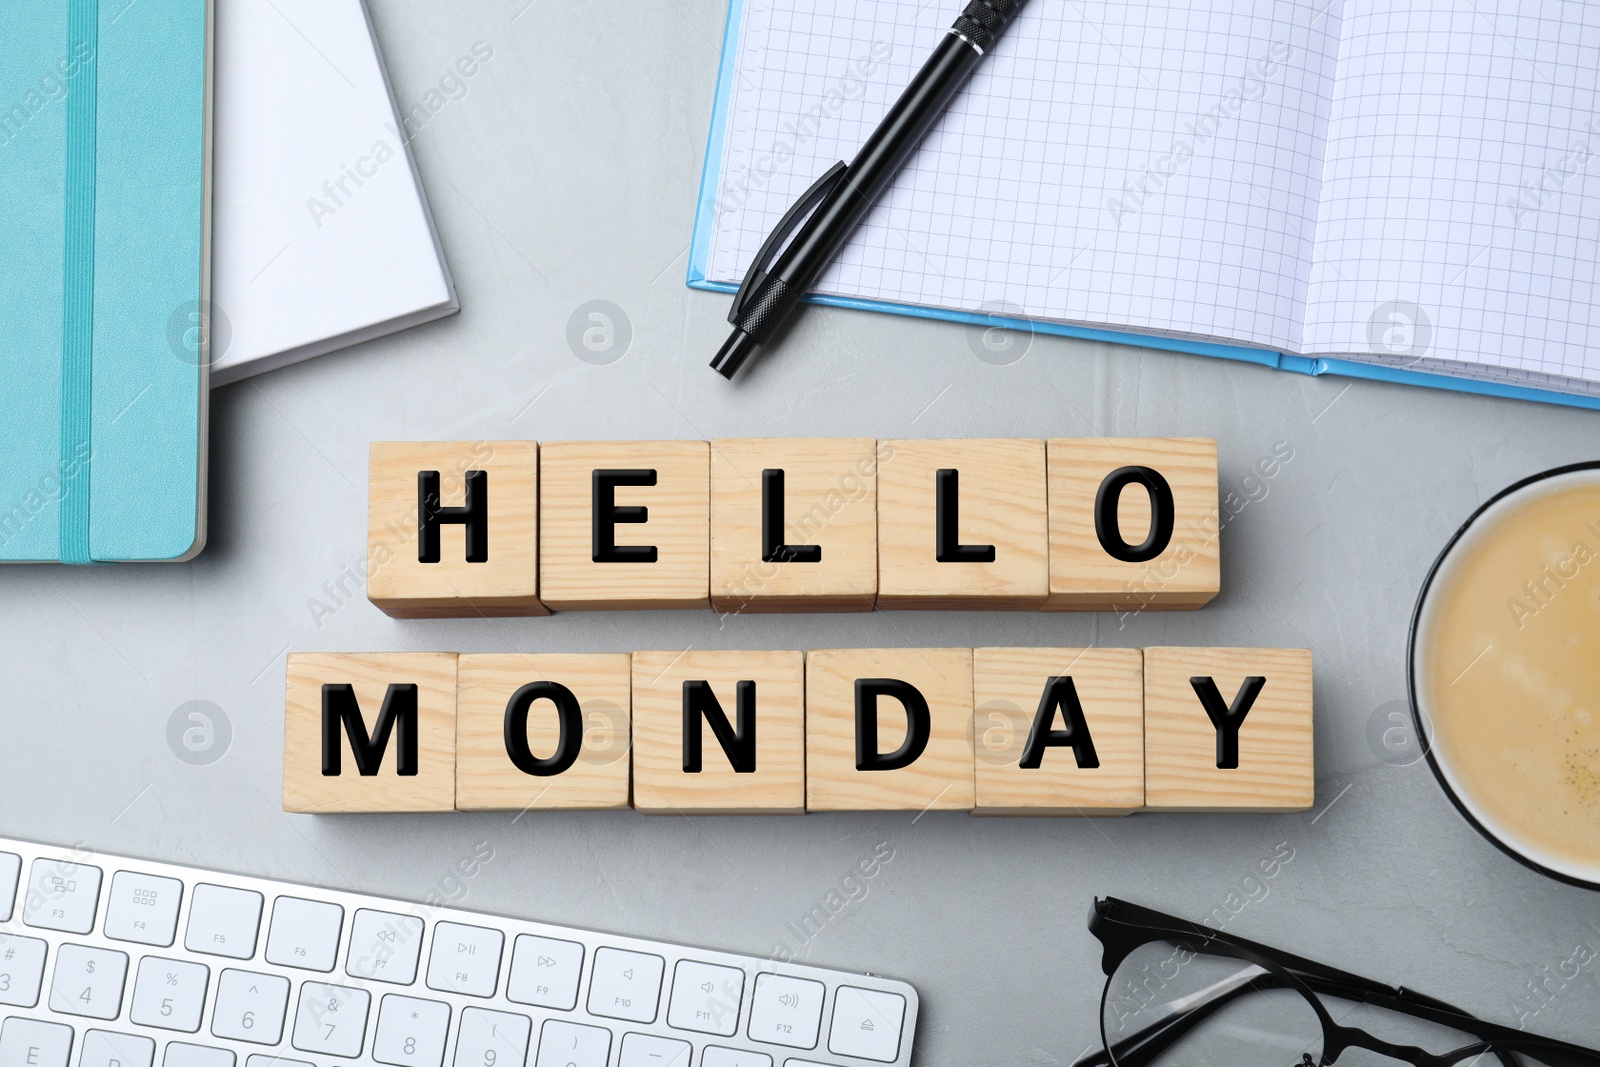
[362,437,1221,617]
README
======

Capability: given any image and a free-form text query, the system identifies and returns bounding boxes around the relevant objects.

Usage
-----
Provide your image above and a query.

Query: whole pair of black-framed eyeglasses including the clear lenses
[1074,897,1600,1067]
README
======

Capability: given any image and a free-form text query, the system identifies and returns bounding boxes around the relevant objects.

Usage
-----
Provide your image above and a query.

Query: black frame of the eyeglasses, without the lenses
[1074,897,1600,1067]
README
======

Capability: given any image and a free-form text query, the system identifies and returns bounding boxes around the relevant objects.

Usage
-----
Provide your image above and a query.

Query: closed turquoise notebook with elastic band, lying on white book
[0,0,213,563]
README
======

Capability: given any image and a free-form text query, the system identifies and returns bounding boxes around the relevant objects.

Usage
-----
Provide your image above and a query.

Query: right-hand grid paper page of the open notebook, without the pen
[1304,0,1600,379]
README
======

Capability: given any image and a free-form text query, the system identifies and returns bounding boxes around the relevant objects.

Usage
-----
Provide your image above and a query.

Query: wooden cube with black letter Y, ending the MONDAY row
[1144,648,1315,811]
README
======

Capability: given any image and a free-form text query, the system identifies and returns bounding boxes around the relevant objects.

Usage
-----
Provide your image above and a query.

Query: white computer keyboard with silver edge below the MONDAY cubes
[0,838,917,1067]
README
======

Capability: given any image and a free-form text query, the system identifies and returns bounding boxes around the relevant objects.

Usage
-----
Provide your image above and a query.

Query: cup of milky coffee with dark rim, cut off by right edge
[1406,461,1600,889]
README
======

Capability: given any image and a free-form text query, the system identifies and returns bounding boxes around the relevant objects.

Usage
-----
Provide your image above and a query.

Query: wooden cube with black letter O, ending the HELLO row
[1045,437,1222,611]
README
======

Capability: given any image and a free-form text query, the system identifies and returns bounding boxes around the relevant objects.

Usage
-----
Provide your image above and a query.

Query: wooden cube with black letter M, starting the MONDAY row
[283,653,456,813]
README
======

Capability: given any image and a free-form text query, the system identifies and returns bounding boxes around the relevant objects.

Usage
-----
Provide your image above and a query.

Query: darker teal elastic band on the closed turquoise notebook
[59,0,99,563]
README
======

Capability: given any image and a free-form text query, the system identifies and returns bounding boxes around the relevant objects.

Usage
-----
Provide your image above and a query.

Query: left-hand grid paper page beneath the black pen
[707,0,1339,350]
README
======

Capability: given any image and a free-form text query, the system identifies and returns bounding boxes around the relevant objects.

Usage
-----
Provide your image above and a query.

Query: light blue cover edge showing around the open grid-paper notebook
[688,0,1600,411]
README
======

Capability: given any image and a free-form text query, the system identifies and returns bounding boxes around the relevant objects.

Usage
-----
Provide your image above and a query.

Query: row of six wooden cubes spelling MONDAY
[283,648,1314,814]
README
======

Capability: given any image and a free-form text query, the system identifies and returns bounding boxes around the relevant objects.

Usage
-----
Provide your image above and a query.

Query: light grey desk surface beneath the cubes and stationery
[0,0,1600,1067]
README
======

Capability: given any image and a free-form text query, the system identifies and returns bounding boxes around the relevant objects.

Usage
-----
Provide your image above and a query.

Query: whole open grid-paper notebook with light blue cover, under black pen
[690,0,1600,408]
